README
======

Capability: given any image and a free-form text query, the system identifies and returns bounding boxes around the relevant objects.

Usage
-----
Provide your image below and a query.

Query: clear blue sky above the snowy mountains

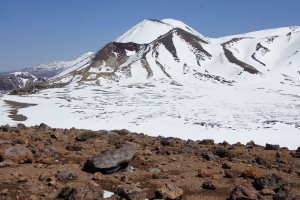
[0,0,300,71]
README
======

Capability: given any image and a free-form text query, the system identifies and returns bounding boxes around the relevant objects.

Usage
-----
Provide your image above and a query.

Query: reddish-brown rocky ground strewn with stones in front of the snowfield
[0,124,300,200]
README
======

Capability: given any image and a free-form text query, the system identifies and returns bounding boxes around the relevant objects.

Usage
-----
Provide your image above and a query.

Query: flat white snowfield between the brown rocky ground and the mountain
[0,78,300,149]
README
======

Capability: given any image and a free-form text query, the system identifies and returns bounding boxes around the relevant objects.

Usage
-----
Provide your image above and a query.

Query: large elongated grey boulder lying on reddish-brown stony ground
[83,142,139,174]
